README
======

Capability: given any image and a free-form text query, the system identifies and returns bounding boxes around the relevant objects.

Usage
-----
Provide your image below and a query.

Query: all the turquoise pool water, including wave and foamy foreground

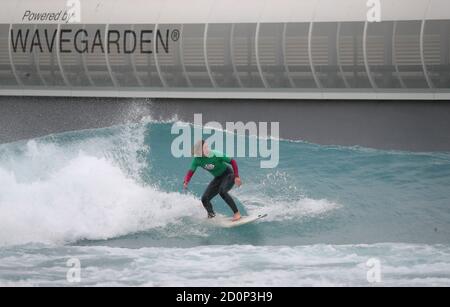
[0,122,450,286]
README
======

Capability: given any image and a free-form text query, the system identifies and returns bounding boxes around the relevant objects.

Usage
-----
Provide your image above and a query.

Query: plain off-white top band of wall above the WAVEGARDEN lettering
[0,0,450,24]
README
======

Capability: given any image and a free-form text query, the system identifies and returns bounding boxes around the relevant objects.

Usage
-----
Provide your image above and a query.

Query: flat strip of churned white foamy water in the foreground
[0,243,450,287]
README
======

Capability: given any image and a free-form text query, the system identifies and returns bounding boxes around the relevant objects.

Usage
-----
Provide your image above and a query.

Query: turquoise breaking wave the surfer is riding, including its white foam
[0,118,450,247]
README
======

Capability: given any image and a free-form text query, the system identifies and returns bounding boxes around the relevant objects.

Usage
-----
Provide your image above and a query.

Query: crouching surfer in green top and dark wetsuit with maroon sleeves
[183,140,242,222]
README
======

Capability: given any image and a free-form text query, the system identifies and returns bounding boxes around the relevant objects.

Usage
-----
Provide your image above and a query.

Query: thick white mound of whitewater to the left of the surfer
[0,154,201,245]
